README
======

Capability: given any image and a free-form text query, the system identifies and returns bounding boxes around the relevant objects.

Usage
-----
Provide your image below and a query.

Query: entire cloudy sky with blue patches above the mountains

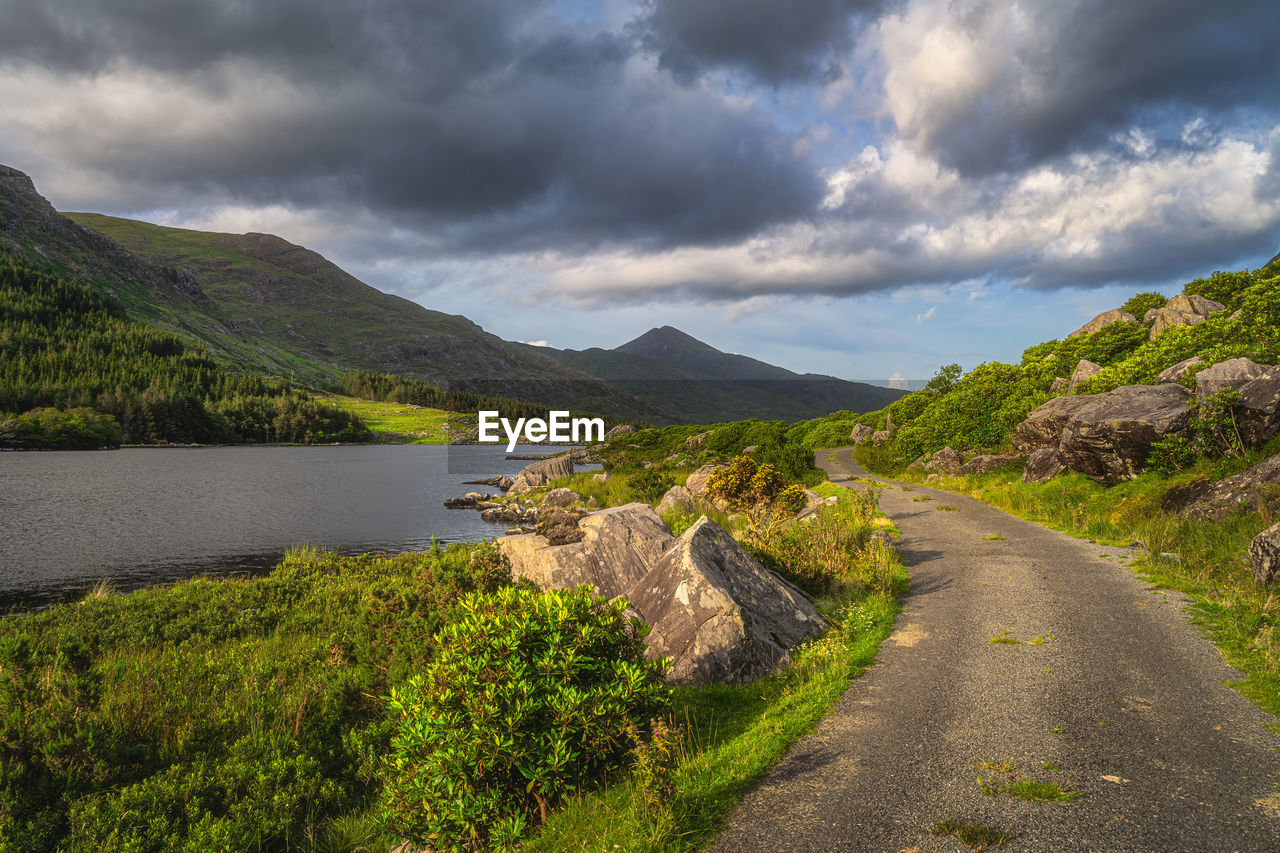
[0,0,1280,379]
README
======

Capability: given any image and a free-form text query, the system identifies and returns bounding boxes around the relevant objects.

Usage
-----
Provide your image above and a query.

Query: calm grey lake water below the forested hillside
[0,444,581,612]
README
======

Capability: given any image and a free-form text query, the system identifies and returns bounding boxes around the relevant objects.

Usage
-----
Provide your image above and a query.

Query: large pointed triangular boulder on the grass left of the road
[626,516,827,684]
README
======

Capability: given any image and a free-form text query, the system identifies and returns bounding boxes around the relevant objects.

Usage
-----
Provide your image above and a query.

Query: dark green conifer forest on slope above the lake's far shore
[0,251,369,448]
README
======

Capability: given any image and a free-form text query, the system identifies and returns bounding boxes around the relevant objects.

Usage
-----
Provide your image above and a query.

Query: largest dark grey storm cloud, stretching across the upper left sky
[0,0,823,250]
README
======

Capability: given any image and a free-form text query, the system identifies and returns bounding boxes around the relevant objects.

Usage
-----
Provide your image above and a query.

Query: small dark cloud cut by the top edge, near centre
[637,0,882,83]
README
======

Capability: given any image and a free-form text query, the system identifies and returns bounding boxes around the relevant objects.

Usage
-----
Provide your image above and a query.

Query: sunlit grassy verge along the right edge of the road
[856,447,1280,715]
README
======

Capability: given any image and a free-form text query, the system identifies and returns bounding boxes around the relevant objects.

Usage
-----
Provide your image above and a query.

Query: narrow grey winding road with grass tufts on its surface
[713,450,1280,853]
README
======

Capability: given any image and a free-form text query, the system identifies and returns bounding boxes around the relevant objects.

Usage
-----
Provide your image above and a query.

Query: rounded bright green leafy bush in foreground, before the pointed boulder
[383,587,669,850]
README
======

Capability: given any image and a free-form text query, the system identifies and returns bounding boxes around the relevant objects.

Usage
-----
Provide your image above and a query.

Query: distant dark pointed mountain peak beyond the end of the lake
[524,325,905,423]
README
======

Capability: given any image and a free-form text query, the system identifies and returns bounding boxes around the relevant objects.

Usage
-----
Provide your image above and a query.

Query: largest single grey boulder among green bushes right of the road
[1046,384,1190,485]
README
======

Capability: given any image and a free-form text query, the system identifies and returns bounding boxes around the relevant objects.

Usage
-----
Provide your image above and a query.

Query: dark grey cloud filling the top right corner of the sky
[890,0,1280,174]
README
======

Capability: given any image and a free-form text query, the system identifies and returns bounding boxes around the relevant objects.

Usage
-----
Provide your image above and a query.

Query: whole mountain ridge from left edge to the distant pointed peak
[0,165,901,424]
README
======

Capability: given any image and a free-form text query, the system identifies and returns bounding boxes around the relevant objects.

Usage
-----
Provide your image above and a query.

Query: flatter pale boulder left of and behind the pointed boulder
[497,503,676,598]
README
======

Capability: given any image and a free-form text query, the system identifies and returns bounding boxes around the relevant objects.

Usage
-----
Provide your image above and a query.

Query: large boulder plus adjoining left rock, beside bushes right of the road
[1014,384,1190,485]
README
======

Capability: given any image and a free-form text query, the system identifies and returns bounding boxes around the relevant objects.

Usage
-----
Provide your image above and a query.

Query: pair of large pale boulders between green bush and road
[498,503,827,684]
